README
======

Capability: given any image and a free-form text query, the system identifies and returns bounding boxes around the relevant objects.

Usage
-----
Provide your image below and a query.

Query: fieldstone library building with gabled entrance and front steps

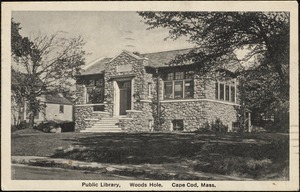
[75,49,239,132]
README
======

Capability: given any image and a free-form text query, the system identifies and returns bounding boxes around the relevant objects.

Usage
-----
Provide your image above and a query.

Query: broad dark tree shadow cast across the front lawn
[53,133,289,164]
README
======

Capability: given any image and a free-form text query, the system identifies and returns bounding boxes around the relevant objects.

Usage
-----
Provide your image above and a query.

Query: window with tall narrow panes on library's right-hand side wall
[215,82,236,103]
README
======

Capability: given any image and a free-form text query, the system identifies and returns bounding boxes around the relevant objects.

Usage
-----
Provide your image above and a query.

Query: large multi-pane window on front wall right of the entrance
[164,71,194,99]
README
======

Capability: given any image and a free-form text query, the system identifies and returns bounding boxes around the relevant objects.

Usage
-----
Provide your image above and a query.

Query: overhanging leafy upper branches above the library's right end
[138,12,289,91]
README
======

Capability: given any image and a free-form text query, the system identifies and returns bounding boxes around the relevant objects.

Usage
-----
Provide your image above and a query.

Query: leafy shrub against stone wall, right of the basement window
[196,118,228,133]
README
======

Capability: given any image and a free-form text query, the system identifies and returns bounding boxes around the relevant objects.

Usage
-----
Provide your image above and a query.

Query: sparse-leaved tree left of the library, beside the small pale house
[11,20,85,127]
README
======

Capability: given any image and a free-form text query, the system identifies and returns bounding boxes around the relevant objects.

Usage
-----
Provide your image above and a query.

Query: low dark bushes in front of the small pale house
[35,120,75,133]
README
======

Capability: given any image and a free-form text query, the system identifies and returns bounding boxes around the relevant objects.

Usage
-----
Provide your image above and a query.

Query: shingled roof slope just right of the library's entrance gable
[141,48,192,68]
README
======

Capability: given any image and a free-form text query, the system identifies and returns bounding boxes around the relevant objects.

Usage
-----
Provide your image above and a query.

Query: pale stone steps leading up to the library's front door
[80,117,122,133]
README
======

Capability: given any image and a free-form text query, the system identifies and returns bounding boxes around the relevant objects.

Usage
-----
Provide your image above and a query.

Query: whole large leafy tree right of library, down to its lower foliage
[138,12,290,129]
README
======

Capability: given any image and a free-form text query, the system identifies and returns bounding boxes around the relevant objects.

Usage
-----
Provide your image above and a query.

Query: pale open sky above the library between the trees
[12,11,194,64]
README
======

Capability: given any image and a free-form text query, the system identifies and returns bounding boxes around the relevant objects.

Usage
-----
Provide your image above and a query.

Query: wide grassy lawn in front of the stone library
[12,132,289,180]
